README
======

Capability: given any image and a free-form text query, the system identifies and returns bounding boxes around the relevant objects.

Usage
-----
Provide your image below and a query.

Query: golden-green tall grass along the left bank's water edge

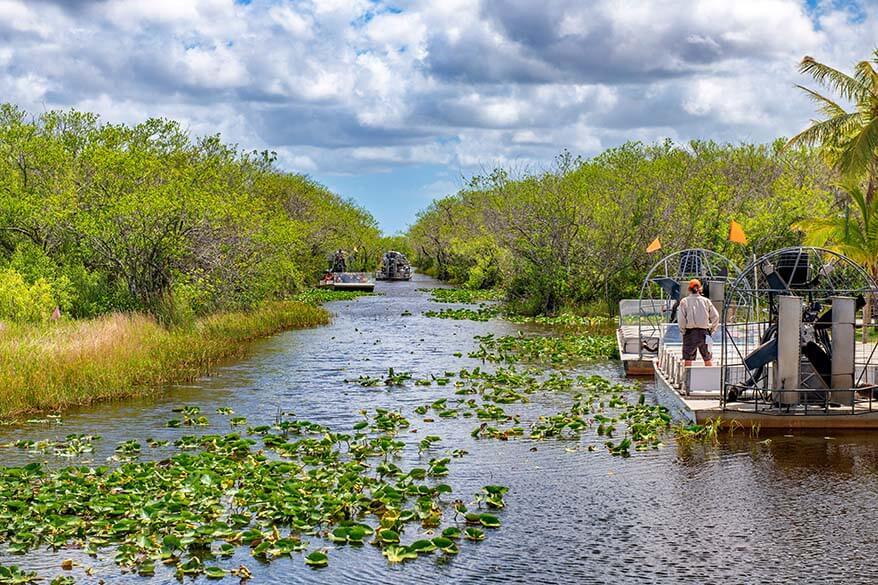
[0,302,329,418]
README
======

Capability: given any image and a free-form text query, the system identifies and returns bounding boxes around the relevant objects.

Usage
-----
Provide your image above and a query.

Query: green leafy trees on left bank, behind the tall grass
[0,104,381,323]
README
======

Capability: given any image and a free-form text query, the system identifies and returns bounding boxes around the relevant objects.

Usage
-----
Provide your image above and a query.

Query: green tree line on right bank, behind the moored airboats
[408,141,843,313]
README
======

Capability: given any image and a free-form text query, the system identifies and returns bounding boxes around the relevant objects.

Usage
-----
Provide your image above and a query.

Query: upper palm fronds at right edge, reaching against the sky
[787,49,878,203]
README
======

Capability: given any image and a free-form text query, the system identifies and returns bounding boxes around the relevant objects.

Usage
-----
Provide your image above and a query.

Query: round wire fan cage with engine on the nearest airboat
[721,247,878,414]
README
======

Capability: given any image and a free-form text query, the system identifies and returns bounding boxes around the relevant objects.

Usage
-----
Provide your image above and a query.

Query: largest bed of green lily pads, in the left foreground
[0,407,506,583]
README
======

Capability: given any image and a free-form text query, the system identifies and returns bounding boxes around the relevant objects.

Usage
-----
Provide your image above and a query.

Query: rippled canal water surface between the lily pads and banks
[0,275,878,584]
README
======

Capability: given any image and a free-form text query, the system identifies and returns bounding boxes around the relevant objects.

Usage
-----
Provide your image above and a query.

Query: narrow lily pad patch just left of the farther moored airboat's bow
[469,333,619,365]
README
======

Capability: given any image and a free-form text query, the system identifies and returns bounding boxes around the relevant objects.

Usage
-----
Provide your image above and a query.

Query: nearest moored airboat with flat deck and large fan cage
[648,247,878,428]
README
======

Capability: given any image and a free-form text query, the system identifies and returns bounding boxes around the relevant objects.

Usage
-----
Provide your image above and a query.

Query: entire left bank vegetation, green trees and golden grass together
[0,104,396,420]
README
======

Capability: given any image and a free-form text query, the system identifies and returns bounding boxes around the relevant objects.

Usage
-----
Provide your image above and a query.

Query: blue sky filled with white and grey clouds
[0,0,878,233]
